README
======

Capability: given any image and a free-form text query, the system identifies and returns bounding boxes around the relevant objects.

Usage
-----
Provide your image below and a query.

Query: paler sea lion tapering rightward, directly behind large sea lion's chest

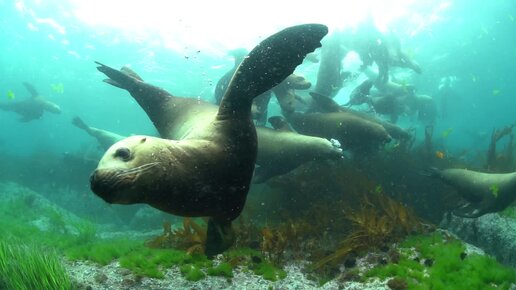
[253,116,342,183]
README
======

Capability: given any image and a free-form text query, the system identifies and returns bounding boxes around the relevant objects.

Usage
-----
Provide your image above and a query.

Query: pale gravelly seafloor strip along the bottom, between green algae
[66,255,392,290]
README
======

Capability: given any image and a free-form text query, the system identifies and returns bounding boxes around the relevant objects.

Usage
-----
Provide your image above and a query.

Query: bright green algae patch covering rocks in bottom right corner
[364,233,516,289]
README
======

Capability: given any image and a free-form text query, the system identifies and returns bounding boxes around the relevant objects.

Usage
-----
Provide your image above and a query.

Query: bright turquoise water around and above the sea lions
[0,0,516,286]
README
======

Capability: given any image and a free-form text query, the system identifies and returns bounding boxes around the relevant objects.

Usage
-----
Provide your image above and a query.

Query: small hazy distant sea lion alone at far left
[0,83,61,122]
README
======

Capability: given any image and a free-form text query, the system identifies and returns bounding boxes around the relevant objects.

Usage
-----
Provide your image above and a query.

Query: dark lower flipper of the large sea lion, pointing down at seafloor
[204,218,236,258]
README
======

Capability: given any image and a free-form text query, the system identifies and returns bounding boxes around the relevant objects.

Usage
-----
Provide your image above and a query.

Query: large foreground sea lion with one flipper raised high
[91,24,328,256]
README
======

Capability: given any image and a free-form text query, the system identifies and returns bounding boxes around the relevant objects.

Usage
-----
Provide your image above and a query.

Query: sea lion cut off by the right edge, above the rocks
[431,169,516,218]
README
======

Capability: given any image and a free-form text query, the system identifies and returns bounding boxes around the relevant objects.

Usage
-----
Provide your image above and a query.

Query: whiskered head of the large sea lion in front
[90,136,163,204]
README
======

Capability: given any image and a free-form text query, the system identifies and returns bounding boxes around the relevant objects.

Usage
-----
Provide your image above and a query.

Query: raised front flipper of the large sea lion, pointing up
[217,24,328,119]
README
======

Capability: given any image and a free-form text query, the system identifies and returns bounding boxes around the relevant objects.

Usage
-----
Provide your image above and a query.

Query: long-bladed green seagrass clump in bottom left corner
[0,240,72,290]
